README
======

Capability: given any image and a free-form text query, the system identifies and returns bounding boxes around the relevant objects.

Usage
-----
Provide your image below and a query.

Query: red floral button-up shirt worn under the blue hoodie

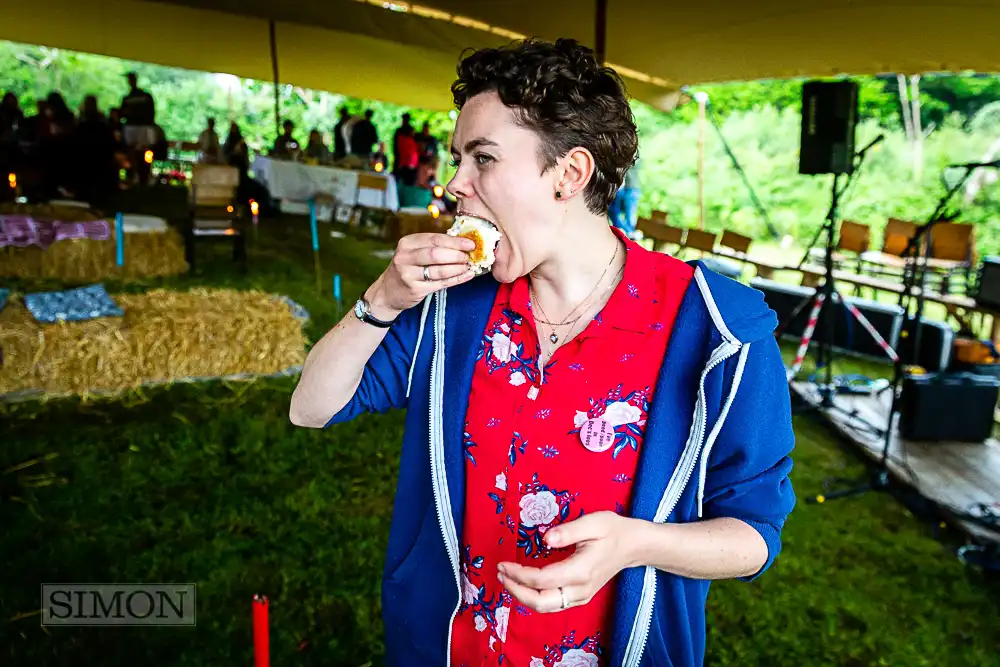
[452,231,694,667]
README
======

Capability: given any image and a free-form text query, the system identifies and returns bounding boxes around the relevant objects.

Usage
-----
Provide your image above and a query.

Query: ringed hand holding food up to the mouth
[365,234,476,320]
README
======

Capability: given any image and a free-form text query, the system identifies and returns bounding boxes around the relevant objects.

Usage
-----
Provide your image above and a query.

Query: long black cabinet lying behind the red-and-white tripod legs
[750,278,903,361]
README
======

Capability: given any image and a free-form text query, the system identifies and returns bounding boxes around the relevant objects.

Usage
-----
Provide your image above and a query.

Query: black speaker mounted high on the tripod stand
[799,81,858,174]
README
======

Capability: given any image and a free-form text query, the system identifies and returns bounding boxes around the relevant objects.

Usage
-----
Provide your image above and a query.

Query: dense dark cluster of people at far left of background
[0,73,168,205]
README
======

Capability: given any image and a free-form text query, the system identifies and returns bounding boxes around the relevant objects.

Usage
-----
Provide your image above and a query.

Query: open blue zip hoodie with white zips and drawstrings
[328,263,795,667]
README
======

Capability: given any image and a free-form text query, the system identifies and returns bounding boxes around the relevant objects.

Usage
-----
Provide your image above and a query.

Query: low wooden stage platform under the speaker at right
[791,382,1000,544]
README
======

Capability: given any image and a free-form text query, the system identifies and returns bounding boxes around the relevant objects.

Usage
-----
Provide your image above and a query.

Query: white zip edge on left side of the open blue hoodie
[430,291,462,667]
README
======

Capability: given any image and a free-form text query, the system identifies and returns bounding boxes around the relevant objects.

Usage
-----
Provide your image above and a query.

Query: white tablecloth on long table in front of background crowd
[253,156,399,211]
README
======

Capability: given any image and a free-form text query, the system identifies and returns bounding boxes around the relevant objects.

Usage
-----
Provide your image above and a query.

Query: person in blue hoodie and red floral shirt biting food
[290,40,794,667]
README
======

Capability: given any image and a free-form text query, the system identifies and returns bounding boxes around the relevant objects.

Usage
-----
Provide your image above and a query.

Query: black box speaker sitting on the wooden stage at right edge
[899,373,1000,442]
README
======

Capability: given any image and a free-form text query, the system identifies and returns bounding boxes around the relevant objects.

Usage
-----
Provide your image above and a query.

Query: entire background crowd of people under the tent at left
[0,73,440,214]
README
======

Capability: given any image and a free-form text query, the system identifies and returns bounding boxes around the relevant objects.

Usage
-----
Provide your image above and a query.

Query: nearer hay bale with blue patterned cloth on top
[0,289,306,396]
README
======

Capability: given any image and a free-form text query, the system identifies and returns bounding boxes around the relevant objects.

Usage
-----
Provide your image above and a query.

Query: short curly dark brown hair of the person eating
[451,39,639,214]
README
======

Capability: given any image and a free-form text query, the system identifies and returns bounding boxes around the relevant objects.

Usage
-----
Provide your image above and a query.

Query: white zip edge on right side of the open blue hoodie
[623,341,741,667]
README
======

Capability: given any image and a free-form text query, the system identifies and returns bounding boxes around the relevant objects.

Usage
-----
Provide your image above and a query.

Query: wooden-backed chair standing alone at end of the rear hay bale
[185,164,246,270]
